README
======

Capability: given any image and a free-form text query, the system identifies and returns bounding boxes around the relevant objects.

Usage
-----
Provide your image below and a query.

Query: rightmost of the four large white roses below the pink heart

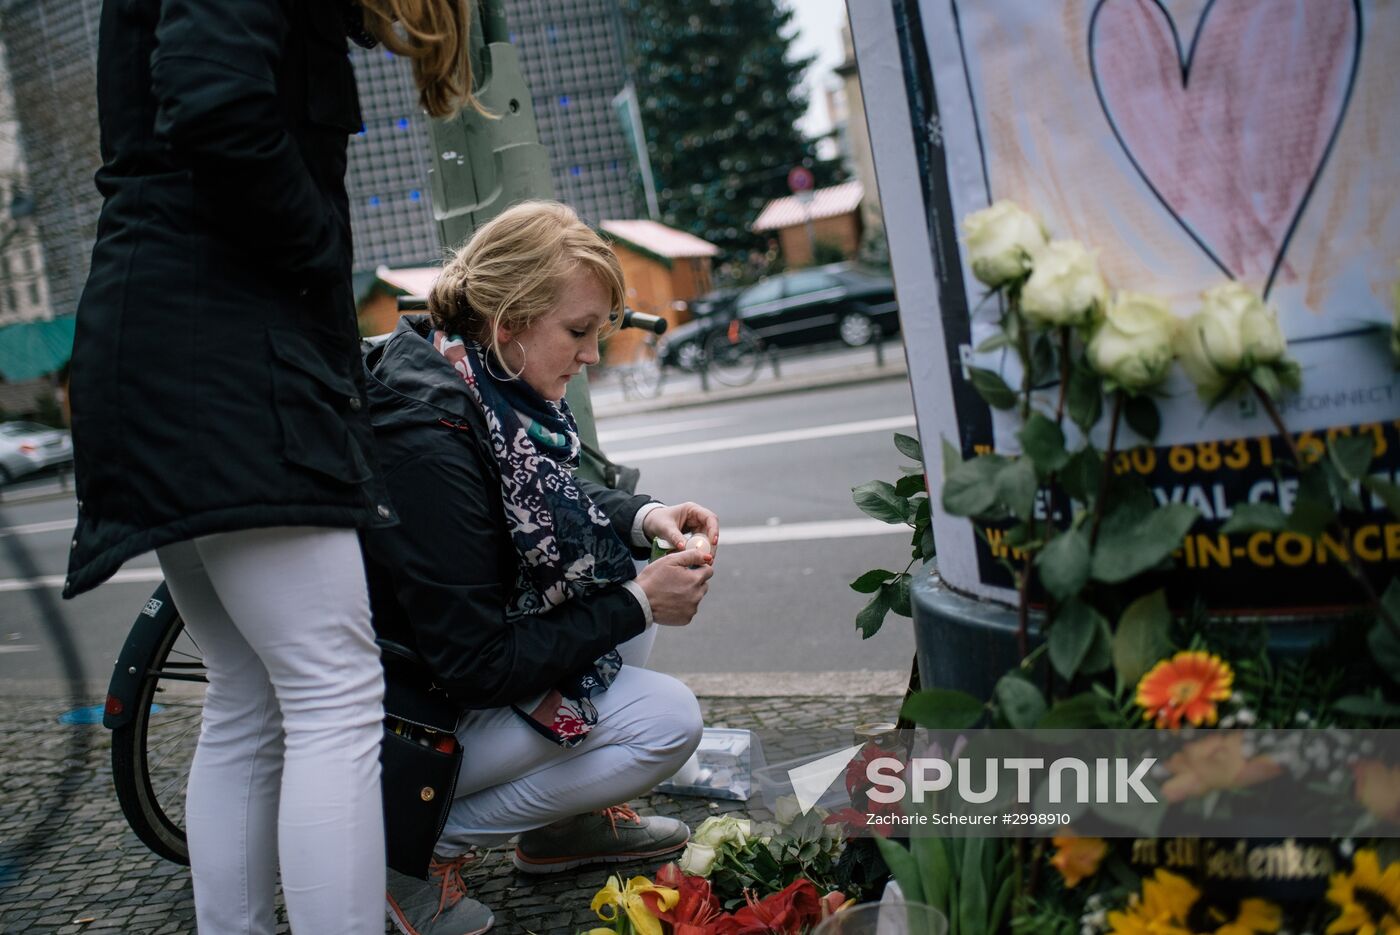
[1176,283,1288,398]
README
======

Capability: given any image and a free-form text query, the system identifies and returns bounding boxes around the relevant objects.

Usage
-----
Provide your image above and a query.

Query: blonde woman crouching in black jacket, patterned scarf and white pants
[365,202,720,935]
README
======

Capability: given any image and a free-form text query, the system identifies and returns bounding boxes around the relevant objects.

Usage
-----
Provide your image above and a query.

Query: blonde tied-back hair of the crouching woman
[428,202,624,360]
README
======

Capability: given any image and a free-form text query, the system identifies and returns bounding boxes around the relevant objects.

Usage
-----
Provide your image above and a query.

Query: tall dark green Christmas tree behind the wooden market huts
[622,0,839,264]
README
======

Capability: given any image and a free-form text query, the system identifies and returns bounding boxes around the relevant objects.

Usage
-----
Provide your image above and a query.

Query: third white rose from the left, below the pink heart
[1088,293,1176,393]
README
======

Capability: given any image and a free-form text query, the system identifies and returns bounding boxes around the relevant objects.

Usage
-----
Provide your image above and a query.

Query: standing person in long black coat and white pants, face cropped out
[64,0,472,935]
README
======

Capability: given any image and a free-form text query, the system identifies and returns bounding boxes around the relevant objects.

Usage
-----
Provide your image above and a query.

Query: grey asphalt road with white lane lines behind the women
[0,379,914,693]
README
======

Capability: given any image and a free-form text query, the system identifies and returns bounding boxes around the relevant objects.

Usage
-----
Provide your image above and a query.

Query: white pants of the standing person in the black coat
[157,528,385,935]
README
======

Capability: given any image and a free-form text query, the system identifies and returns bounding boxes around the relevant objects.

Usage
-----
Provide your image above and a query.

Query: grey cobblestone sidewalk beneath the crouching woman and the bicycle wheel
[0,697,899,935]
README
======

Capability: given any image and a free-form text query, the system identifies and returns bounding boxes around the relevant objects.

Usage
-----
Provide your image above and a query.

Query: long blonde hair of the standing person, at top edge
[360,0,496,118]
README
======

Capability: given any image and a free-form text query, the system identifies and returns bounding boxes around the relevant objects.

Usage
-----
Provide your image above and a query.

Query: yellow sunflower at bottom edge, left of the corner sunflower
[1109,869,1284,935]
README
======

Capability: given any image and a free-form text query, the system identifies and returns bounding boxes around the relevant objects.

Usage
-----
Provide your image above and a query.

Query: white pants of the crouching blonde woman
[437,626,701,857]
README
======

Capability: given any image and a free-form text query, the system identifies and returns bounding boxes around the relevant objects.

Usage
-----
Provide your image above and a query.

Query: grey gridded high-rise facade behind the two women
[0,0,641,315]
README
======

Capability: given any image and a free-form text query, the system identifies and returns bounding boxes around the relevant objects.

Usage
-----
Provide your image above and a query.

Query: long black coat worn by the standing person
[64,0,393,596]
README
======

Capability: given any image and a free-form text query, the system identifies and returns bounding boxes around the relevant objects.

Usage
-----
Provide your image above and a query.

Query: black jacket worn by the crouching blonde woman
[365,315,651,708]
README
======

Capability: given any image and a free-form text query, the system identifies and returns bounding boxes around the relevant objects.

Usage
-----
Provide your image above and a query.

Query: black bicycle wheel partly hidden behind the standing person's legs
[112,614,206,864]
